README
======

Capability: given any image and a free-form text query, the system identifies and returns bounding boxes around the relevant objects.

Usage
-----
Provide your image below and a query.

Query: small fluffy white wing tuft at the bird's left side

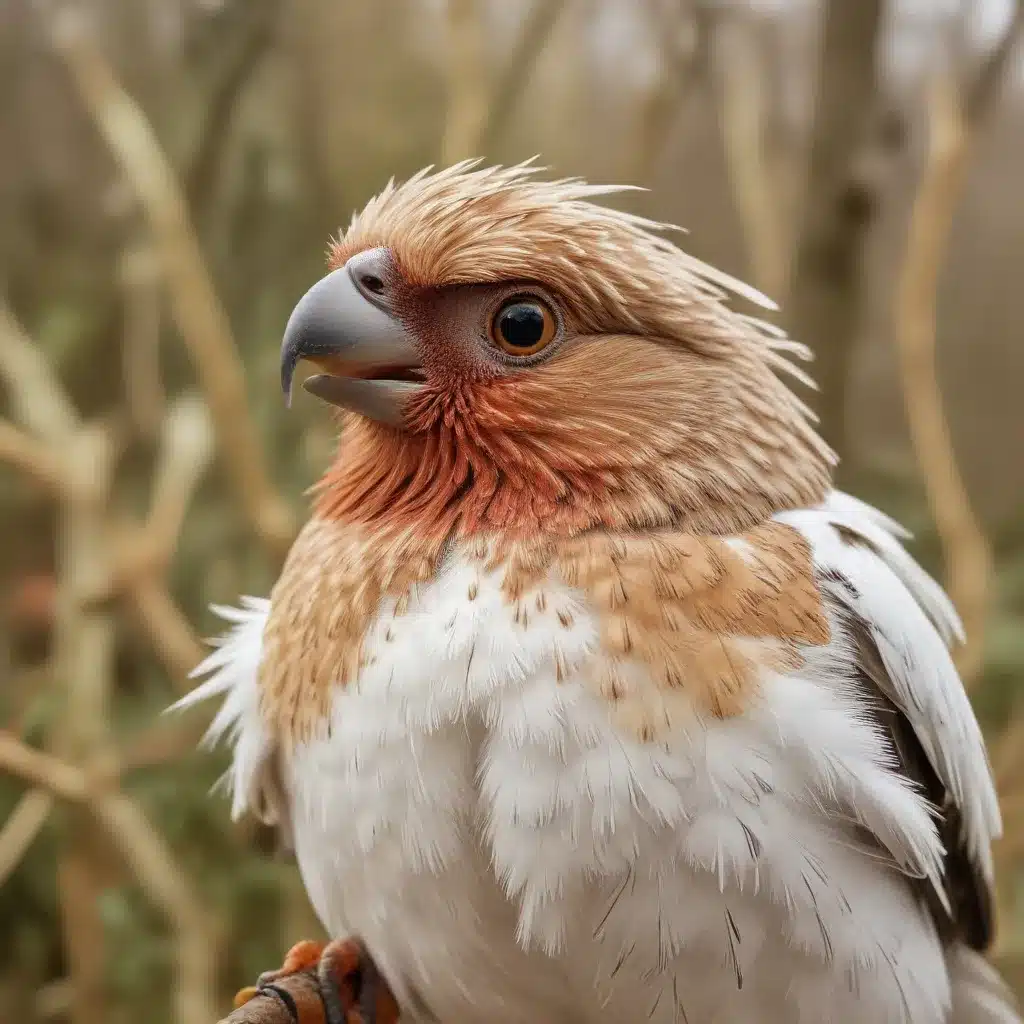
[168,597,291,845]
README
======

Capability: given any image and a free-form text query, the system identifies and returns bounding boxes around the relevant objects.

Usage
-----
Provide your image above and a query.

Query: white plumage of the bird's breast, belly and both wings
[176,495,1009,1024]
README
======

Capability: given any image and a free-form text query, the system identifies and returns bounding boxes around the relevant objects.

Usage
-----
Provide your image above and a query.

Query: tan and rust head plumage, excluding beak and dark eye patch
[322,161,833,532]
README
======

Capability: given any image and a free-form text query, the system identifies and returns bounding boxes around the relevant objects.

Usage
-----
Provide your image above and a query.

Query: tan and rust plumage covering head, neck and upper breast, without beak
[261,162,833,738]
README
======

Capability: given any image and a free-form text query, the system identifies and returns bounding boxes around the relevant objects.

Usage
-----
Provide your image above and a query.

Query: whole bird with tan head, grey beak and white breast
[176,161,1021,1024]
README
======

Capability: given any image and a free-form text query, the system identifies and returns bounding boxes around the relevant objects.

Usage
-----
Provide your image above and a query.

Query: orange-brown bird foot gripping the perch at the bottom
[228,938,398,1024]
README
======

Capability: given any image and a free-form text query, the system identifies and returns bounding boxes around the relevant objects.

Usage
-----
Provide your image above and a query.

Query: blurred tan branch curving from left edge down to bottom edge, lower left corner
[0,730,216,1024]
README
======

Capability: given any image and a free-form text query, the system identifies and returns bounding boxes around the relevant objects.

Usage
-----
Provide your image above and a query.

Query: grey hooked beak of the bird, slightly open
[281,249,423,427]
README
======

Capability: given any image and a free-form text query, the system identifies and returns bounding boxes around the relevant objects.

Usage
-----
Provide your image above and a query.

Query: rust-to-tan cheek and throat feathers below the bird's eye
[315,336,829,536]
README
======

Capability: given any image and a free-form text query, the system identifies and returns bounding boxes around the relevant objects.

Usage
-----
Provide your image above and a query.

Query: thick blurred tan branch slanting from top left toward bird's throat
[53,10,295,557]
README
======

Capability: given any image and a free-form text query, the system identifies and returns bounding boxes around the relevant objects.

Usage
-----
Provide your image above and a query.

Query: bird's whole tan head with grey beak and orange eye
[282,162,833,536]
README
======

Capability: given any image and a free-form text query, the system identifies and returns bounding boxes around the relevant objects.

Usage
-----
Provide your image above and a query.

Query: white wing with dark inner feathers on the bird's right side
[778,493,1000,949]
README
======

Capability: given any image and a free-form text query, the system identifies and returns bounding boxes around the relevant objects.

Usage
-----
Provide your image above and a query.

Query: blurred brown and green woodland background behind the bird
[0,0,1024,1024]
